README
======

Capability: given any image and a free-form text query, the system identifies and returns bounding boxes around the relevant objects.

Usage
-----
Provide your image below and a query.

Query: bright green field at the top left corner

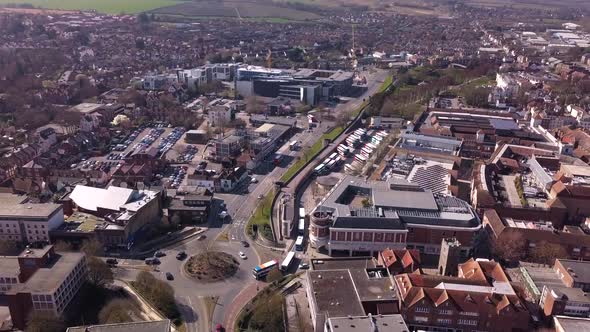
[0,0,179,14]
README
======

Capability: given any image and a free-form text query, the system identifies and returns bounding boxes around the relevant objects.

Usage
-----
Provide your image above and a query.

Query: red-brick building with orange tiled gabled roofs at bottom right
[393,259,530,332]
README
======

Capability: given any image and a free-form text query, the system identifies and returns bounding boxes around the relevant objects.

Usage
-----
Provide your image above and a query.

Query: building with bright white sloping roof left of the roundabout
[60,185,161,248]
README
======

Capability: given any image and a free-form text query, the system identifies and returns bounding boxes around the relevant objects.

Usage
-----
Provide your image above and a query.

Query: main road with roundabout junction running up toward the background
[116,67,394,332]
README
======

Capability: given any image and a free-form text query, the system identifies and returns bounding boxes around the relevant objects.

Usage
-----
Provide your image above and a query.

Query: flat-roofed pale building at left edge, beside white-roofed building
[0,194,64,243]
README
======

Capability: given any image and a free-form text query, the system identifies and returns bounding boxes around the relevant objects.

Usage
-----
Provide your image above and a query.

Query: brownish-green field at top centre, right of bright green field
[153,0,321,21]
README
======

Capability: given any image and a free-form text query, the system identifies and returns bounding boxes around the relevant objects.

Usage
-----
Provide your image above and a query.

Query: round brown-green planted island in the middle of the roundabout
[184,251,240,282]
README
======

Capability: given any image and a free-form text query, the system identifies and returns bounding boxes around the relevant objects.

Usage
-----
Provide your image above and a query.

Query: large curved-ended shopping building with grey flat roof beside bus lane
[309,176,481,255]
